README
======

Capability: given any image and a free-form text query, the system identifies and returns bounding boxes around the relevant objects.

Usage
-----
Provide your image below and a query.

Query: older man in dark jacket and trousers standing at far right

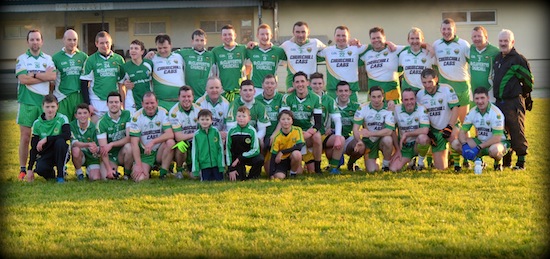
[493,29,534,170]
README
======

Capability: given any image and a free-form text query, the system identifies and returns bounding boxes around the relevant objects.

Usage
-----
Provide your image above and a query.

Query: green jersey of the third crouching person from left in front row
[97,110,131,152]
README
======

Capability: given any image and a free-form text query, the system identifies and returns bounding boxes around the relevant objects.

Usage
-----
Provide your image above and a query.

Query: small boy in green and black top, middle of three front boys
[226,106,264,181]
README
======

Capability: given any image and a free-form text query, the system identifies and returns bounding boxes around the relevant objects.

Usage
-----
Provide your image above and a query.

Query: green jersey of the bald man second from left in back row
[52,48,88,102]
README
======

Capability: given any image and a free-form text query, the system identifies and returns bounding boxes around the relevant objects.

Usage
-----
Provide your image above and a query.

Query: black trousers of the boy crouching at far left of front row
[34,138,69,179]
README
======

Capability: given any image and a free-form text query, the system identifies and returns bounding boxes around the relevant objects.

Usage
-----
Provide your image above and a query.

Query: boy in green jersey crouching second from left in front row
[70,103,101,181]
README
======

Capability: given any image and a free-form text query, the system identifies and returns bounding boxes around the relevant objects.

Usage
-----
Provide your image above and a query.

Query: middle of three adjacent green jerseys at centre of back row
[212,44,246,92]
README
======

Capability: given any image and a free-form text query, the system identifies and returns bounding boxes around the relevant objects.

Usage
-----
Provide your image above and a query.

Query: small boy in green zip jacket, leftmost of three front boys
[191,109,225,181]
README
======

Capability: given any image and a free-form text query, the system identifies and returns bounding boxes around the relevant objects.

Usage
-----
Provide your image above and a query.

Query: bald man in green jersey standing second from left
[52,29,88,121]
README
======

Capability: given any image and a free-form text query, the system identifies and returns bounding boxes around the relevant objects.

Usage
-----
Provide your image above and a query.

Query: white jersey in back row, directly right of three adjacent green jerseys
[281,39,326,86]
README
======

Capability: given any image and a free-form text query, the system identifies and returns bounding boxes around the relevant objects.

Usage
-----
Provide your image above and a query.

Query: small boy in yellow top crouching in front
[269,110,305,179]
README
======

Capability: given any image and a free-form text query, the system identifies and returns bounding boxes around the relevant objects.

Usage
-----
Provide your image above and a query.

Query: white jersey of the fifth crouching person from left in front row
[168,102,201,134]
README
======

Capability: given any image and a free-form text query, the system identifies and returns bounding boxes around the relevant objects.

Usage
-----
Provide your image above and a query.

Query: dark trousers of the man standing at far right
[496,95,528,156]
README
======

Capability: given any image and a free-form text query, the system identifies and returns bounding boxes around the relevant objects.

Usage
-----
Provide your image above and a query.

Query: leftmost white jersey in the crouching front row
[130,106,171,151]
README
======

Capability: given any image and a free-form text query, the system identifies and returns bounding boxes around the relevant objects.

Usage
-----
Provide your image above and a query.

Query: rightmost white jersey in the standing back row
[433,36,470,82]
